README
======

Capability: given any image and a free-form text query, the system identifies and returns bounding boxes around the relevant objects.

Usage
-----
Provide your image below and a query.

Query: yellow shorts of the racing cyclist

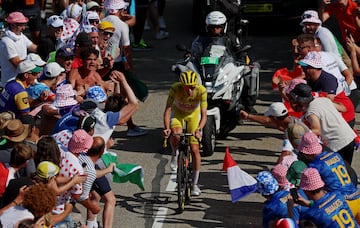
[170,108,201,144]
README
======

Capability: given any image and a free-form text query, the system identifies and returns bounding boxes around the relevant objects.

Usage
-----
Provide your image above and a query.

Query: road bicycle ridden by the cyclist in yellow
[164,130,193,213]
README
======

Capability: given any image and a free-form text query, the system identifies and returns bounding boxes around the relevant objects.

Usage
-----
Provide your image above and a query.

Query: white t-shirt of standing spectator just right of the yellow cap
[102,15,130,62]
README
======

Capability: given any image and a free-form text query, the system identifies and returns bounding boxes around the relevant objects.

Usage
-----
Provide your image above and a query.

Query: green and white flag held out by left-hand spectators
[101,152,145,190]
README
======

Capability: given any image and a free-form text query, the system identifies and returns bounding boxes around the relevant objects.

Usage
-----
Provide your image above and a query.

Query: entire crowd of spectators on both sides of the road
[0,0,360,228]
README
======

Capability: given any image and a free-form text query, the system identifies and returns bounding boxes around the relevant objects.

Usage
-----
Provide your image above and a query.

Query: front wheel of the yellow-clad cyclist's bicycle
[177,150,187,212]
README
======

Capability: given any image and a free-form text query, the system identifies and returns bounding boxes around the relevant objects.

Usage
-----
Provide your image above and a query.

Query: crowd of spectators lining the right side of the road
[240,0,360,227]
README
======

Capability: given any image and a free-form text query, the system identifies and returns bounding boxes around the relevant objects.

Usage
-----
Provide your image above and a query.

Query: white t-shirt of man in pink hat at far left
[0,29,33,86]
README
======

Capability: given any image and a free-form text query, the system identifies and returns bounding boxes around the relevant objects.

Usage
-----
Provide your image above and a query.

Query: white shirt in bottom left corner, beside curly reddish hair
[0,206,34,228]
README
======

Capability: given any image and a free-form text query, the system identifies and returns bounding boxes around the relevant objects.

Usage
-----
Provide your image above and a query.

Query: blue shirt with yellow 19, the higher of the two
[309,151,357,196]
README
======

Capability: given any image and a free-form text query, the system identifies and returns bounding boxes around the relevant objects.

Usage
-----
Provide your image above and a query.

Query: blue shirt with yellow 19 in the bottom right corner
[301,192,359,228]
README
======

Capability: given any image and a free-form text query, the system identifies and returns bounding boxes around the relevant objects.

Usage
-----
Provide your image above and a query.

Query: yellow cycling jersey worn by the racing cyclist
[167,82,207,114]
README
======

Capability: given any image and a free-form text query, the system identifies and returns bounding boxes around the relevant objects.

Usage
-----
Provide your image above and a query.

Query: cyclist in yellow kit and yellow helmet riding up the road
[163,70,207,196]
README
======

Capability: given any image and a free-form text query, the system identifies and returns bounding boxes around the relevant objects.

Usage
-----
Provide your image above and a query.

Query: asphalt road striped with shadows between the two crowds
[74,0,360,228]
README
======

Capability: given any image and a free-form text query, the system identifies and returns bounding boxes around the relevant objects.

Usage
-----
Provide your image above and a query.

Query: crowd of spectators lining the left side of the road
[0,0,168,228]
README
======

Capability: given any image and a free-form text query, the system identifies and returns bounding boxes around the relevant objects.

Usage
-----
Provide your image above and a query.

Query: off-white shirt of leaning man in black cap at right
[305,97,356,151]
